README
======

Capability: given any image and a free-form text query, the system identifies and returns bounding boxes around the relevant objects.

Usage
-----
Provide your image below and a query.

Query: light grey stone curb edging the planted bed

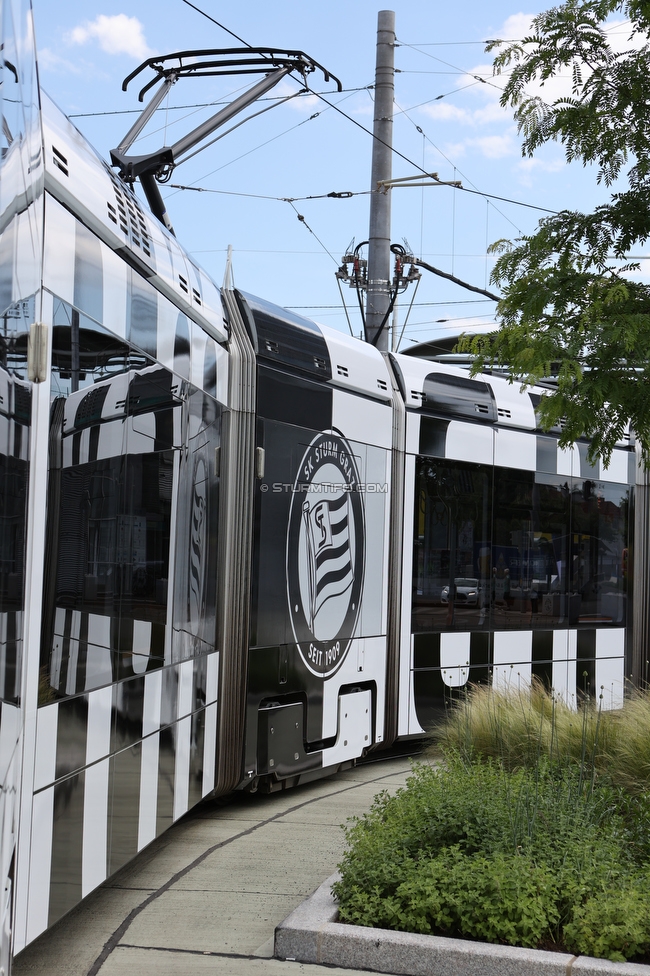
[274,874,650,976]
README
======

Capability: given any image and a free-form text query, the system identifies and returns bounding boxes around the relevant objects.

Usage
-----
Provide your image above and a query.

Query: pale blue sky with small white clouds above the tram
[26,0,650,349]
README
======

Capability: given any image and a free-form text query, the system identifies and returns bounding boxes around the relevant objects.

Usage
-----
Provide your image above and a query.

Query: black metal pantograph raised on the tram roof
[111,47,342,233]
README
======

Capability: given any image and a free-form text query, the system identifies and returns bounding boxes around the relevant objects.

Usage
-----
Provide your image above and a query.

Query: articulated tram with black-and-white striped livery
[0,0,639,972]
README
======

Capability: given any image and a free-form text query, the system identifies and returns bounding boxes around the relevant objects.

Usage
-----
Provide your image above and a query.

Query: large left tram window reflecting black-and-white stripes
[40,299,221,704]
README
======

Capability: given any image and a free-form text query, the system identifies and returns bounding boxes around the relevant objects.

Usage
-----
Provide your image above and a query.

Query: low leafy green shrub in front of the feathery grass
[335,752,650,958]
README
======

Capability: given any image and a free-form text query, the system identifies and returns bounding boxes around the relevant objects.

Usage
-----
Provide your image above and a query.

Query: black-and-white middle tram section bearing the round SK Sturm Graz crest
[238,300,391,788]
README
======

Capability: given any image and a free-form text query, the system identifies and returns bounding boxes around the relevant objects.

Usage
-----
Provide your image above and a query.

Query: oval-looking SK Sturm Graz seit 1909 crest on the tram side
[287,431,365,677]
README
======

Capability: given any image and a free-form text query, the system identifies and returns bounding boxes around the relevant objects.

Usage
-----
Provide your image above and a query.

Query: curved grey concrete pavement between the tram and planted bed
[12,759,410,976]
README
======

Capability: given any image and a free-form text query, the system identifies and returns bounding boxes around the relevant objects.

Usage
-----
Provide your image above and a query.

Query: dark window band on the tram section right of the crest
[412,457,629,633]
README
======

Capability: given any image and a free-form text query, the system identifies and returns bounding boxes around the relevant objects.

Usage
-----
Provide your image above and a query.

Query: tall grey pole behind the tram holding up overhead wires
[366,10,395,350]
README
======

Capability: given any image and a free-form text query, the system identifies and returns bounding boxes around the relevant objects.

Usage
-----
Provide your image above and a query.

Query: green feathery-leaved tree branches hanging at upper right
[463,0,650,465]
